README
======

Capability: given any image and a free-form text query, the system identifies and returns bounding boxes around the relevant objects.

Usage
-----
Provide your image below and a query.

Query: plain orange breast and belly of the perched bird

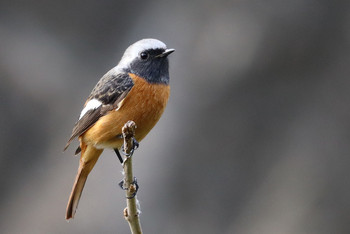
[79,74,170,148]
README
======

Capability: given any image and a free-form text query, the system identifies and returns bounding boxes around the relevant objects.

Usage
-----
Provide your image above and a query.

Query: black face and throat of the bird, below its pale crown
[127,49,169,84]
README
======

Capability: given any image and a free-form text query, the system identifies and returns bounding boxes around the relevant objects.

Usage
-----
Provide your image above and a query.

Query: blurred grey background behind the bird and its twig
[0,0,350,234]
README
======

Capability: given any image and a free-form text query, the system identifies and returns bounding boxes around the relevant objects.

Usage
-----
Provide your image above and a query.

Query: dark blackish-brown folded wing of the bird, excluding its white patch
[64,72,134,150]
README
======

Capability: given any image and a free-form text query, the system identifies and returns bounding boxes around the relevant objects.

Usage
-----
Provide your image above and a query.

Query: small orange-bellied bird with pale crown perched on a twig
[64,38,175,220]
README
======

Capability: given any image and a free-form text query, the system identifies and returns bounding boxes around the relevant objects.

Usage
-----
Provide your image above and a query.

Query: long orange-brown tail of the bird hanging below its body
[66,144,103,219]
